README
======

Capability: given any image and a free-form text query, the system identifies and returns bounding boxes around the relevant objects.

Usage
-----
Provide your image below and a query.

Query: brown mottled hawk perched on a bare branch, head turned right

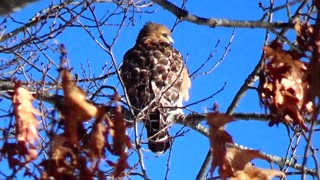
[121,22,191,154]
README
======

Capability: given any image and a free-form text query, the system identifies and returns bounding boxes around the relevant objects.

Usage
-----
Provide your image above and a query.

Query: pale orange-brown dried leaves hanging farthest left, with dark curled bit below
[1,82,41,171]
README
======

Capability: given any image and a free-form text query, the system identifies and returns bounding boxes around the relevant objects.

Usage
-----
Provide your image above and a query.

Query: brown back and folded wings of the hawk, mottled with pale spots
[122,41,185,112]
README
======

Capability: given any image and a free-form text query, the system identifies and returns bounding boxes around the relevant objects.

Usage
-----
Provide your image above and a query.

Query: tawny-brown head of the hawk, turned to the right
[137,22,173,44]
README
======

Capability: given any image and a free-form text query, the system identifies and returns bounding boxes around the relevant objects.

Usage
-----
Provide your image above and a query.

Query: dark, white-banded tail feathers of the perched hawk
[145,113,171,155]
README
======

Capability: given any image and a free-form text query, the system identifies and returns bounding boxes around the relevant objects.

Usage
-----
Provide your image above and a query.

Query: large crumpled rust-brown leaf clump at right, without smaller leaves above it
[259,42,312,130]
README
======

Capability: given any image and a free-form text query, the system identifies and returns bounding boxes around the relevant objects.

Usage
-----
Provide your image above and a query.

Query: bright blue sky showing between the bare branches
[0,0,318,179]
